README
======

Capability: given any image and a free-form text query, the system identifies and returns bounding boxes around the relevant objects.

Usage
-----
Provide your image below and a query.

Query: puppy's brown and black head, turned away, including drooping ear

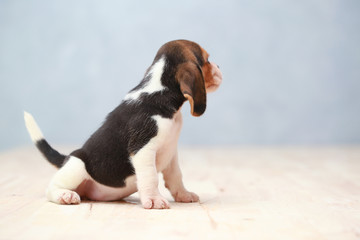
[155,40,222,116]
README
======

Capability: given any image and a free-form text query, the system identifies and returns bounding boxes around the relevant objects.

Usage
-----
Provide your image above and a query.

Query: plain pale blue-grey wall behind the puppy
[0,0,360,150]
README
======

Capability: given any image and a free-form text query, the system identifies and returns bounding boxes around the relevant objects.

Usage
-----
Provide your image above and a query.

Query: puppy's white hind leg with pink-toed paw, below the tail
[46,156,89,204]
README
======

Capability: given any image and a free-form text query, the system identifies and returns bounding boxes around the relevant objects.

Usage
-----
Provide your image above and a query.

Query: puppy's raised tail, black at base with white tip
[24,112,67,168]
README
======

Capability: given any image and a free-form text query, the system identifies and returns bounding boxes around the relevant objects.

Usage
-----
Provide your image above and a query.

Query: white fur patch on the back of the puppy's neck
[124,57,165,100]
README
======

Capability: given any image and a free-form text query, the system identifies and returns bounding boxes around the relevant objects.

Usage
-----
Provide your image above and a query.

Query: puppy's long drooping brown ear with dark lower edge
[176,62,206,117]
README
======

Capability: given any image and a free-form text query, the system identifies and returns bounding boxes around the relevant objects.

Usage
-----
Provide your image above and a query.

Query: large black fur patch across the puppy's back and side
[71,86,184,187]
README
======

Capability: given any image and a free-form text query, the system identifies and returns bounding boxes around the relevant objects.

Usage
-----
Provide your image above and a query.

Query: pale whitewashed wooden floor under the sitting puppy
[0,146,360,240]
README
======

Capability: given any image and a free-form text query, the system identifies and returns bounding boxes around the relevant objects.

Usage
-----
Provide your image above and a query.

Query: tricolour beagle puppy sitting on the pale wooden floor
[24,40,222,209]
